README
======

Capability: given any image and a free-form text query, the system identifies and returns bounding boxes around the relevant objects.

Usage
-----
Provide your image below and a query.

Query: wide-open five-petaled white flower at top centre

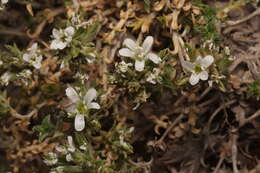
[119,36,161,71]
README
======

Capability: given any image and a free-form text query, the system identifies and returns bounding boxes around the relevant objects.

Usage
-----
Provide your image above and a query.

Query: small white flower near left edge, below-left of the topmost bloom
[23,43,42,69]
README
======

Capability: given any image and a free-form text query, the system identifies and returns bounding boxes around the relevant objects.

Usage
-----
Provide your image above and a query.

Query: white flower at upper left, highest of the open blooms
[50,26,75,50]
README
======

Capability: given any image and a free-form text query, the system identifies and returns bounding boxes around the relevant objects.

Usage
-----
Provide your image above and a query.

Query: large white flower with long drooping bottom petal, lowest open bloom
[66,87,100,131]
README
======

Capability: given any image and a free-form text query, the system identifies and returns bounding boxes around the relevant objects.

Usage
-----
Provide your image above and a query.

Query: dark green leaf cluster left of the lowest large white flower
[33,115,55,141]
